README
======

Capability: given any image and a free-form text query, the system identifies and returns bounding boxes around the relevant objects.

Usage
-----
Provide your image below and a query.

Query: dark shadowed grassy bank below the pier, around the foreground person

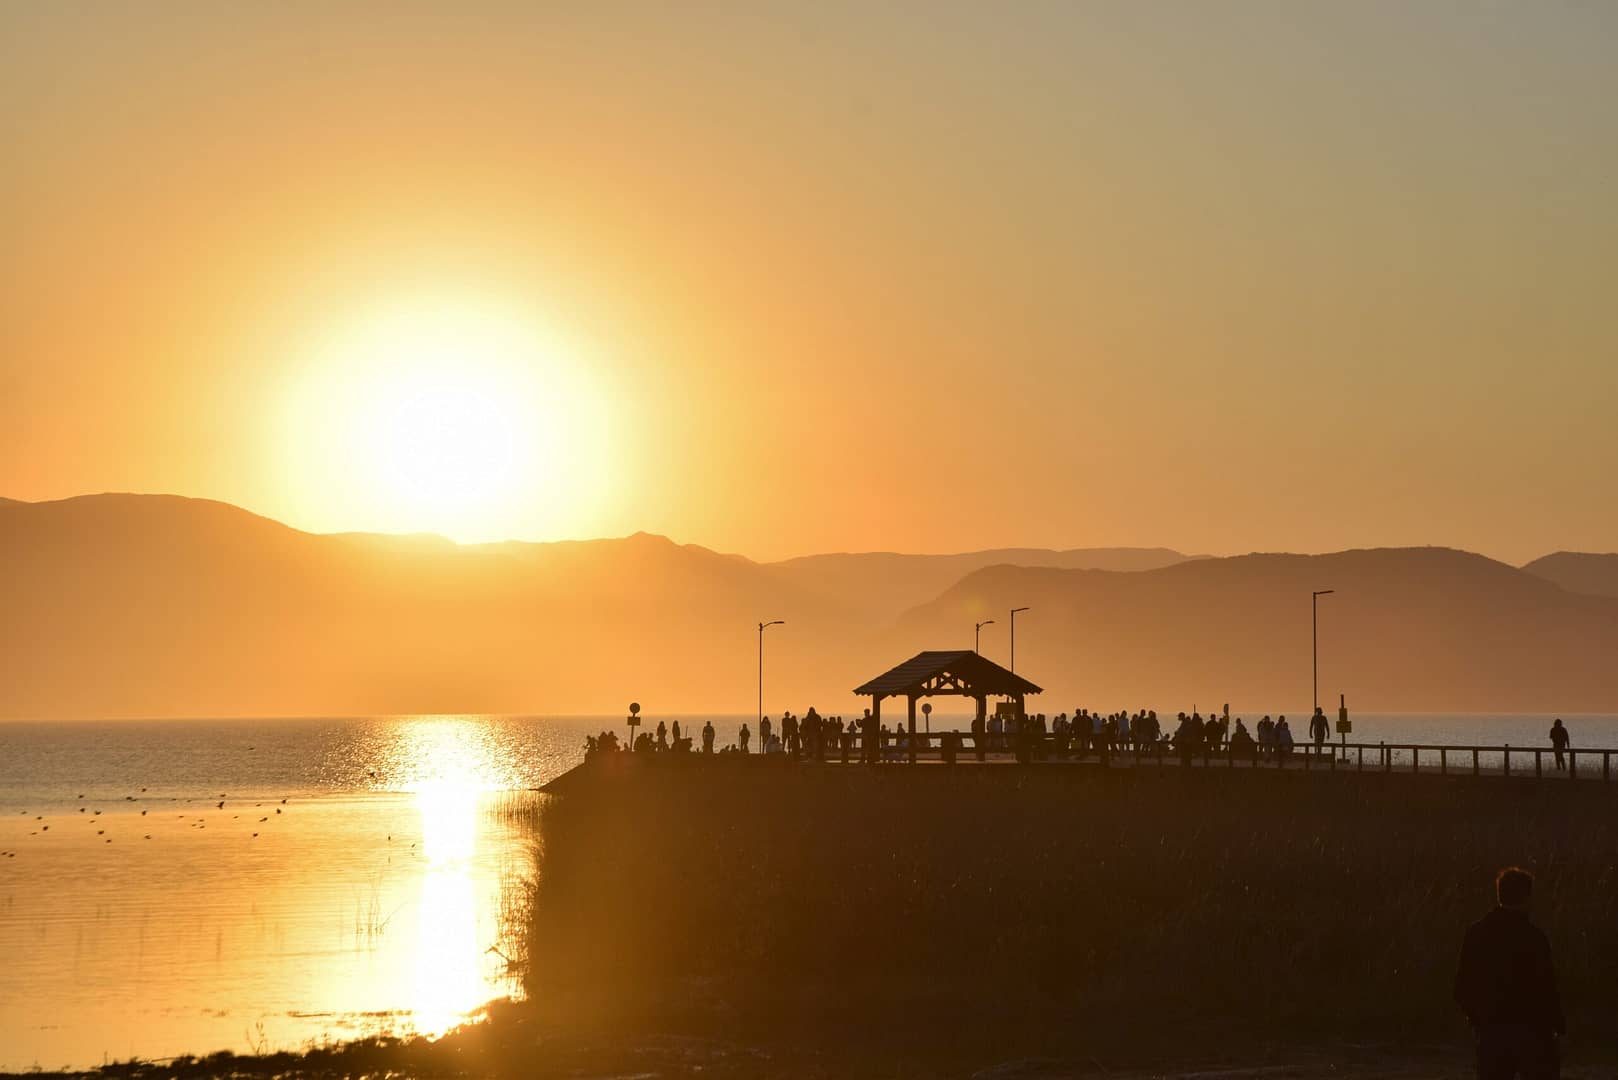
[529,761,1618,1061]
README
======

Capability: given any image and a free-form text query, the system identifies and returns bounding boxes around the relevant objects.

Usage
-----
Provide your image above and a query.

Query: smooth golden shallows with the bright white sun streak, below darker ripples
[0,717,532,1070]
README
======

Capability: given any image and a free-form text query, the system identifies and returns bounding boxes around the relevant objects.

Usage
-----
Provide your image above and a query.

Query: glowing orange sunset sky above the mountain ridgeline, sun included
[0,2,1618,562]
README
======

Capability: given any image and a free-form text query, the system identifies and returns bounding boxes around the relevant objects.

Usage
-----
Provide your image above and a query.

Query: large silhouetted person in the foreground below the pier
[1455,866,1566,1080]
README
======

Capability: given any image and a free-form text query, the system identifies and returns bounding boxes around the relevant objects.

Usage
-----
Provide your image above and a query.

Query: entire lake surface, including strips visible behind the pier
[0,712,1618,1070]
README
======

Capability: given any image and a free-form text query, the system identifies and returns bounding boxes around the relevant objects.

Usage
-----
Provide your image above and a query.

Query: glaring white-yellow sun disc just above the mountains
[288,303,605,541]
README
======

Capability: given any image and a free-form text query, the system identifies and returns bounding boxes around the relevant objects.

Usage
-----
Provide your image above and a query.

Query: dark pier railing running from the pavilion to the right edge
[854,732,1618,782]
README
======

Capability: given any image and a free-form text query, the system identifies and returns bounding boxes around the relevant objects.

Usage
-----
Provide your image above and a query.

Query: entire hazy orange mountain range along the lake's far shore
[0,495,1618,719]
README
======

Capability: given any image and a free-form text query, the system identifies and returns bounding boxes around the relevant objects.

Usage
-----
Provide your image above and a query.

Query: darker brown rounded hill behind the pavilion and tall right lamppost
[901,547,1618,712]
